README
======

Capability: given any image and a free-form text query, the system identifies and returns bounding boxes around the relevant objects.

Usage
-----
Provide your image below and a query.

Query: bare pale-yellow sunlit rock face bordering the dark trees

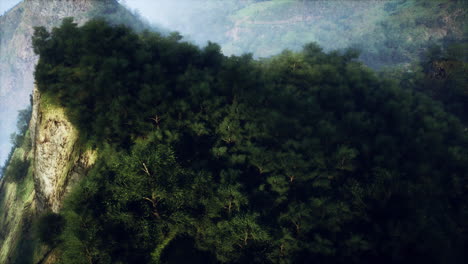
[30,86,95,213]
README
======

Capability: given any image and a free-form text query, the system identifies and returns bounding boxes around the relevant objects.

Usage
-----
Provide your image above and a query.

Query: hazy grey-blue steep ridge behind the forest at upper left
[0,0,145,165]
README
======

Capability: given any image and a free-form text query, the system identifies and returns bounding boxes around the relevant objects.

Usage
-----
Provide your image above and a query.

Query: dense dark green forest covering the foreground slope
[29,19,468,264]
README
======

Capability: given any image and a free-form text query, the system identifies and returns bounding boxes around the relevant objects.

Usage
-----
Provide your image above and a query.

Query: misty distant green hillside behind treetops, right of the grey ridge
[151,0,467,68]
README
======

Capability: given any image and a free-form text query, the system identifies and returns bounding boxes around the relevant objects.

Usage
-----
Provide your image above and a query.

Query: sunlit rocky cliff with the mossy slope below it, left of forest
[0,85,96,263]
